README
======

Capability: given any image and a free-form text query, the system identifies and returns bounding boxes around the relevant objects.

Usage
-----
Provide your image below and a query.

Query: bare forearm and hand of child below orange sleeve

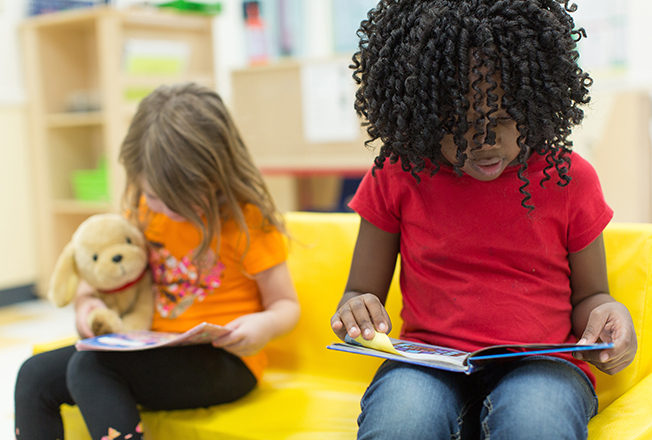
[213,262,300,356]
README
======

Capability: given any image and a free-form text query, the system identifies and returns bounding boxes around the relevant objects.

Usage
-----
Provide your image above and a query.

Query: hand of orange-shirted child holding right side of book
[213,312,273,357]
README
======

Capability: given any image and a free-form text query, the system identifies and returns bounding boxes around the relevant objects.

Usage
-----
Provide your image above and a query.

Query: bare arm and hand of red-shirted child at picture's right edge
[568,234,637,374]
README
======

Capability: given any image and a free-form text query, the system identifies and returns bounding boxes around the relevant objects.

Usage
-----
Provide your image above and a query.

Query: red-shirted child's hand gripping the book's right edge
[575,301,637,374]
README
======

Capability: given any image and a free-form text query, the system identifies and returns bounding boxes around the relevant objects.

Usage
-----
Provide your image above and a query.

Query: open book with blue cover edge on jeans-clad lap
[328,332,613,374]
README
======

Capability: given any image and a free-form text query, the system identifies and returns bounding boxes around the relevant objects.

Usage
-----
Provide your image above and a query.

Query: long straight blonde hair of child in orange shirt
[120,83,285,259]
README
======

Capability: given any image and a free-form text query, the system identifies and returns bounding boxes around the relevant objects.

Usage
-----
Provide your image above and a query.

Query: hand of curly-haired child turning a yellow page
[331,293,392,340]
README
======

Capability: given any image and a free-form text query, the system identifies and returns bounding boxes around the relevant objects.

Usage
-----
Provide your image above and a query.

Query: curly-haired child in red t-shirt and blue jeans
[331,0,636,440]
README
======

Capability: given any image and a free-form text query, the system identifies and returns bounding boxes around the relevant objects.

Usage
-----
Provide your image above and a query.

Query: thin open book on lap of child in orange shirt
[75,322,231,351]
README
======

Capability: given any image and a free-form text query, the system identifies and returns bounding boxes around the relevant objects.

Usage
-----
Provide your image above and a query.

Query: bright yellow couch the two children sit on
[43,213,652,440]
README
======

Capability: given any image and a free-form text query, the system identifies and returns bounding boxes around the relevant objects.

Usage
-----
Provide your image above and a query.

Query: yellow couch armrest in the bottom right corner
[589,374,652,440]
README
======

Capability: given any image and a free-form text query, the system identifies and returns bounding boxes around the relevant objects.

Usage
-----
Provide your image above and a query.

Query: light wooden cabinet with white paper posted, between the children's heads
[231,59,377,211]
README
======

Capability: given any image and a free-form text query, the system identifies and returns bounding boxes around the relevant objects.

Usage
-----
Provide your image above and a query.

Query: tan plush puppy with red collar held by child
[48,214,154,335]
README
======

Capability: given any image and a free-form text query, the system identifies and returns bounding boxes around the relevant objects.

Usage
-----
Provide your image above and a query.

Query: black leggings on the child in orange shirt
[15,345,256,440]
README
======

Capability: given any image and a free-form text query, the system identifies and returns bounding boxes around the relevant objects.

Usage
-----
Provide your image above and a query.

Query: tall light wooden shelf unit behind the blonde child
[21,8,215,294]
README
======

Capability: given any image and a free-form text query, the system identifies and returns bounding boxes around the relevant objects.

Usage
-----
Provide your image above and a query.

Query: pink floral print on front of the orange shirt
[149,244,224,319]
